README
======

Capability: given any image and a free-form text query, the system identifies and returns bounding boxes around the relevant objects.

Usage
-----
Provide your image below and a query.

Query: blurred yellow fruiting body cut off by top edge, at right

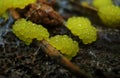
[93,0,113,9]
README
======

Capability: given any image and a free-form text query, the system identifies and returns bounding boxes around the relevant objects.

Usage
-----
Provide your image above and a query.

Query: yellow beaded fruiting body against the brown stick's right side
[48,35,79,59]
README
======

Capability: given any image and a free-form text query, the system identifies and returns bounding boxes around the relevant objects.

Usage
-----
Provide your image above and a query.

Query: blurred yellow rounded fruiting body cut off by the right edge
[98,5,120,28]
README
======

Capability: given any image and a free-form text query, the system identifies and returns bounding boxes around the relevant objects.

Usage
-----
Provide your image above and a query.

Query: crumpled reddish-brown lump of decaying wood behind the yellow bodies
[25,3,63,25]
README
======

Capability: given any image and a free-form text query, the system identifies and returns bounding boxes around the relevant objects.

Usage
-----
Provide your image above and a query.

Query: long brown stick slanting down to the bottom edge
[38,40,92,78]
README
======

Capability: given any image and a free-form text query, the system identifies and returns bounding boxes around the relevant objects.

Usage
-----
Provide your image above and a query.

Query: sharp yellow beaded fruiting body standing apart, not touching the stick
[66,17,97,44]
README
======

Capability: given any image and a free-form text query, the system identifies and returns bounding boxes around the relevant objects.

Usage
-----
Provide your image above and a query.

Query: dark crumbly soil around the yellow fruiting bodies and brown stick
[0,0,120,78]
